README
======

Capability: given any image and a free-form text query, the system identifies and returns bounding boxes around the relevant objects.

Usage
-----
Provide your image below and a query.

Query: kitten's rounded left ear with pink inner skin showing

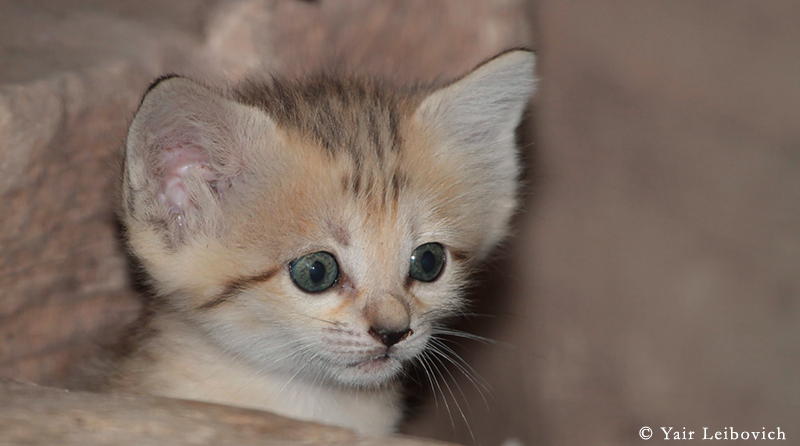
[123,77,275,240]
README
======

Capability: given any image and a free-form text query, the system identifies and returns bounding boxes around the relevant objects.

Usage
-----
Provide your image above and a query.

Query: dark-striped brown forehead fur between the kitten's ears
[239,76,438,247]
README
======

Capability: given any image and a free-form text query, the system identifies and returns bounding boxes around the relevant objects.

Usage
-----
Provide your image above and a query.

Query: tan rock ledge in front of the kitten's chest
[0,380,456,446]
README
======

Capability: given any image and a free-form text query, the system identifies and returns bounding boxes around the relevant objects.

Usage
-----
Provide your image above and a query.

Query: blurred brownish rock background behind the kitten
[0,0,800,446]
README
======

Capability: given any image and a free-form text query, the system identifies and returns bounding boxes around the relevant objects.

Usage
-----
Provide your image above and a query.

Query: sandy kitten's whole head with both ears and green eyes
[122,50,534,386]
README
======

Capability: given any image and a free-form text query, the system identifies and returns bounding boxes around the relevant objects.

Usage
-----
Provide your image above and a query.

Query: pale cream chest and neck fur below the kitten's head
[117,315,402,434]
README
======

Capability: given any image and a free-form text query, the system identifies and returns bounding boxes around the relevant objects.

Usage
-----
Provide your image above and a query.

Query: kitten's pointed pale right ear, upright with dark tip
[415,50,536,257]
